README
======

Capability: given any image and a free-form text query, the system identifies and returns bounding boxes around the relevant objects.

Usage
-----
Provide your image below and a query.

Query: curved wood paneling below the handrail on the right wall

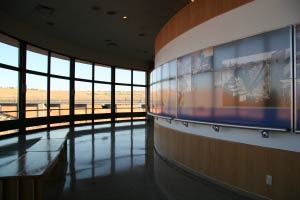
[154,124,300,200]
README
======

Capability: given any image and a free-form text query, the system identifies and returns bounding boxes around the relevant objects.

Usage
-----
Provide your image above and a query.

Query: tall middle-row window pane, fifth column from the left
[94,83,111,114]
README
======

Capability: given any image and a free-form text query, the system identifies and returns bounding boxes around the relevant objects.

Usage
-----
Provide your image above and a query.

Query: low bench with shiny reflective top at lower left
[0,130,67,200]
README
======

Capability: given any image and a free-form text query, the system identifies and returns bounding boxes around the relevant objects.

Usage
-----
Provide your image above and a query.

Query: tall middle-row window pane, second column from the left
[26,74,47,118]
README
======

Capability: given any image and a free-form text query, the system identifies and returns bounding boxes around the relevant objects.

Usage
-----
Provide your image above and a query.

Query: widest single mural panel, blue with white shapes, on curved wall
[214,27,291,128]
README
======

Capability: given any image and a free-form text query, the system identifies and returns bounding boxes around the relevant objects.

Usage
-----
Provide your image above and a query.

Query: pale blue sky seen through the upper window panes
[0,42,145,91]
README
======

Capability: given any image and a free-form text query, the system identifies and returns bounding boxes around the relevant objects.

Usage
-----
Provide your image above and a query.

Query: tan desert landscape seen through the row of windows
[0,88,145,124]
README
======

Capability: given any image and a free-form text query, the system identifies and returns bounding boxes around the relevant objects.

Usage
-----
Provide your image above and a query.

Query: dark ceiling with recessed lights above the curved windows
[0,0,190,69]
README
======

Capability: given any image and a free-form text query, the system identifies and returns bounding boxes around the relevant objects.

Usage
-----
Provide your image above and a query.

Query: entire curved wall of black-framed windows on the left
[0,33,147,135]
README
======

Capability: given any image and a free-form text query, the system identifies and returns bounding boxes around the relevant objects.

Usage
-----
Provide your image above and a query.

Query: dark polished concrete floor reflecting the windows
[0,122,252,200]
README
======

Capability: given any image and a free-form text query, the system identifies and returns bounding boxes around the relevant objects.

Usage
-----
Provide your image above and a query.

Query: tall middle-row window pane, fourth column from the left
[75,81,92,115]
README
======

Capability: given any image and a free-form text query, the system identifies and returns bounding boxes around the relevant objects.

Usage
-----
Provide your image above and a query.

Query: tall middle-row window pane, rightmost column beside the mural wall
[133,87,146,112]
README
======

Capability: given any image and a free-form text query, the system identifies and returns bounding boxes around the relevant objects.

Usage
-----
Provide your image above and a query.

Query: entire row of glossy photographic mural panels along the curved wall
[151,25,290,129]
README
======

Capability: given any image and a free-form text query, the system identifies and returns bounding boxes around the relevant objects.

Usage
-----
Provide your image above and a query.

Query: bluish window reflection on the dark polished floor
[65,122,146,188]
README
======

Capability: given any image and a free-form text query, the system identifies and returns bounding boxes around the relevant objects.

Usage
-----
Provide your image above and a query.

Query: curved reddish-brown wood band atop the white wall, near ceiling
[155,0,253,54]
